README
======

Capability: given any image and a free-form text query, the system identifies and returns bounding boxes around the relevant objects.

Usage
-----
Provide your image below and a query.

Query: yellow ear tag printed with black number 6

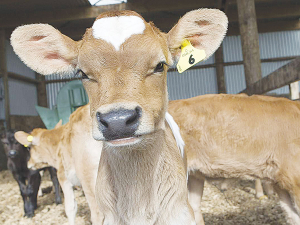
[177,39,206,73]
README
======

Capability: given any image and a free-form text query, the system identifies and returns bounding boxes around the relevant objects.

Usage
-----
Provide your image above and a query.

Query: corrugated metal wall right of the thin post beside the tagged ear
[223,31,300,95]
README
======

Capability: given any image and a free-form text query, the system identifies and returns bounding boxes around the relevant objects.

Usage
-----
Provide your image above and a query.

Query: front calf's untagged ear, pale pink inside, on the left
[10,24,78,75]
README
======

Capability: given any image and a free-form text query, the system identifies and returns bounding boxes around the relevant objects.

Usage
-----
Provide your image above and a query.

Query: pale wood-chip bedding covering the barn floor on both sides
[0,171,287,225]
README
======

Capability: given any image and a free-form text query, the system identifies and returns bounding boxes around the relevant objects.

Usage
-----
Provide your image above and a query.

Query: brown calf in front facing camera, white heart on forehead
[11,9,228,225]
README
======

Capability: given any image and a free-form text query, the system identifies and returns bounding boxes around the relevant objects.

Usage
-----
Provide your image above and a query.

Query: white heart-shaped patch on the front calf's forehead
[92,16,146,51]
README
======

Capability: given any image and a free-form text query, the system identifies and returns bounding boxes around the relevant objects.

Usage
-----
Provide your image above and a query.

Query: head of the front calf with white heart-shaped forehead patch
[11,9,228,146]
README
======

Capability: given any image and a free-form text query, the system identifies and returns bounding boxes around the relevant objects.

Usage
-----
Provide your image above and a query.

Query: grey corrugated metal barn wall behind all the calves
[0,31,300,114]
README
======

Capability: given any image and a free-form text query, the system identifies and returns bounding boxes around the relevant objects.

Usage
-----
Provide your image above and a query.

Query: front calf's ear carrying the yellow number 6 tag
[167,9,228,60]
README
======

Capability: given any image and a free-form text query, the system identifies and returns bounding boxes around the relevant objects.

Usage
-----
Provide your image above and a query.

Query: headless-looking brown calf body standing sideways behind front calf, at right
[168,94,300,225]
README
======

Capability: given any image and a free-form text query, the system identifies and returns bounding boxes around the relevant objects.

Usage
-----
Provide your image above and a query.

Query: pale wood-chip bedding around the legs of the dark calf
[0,171,91,225]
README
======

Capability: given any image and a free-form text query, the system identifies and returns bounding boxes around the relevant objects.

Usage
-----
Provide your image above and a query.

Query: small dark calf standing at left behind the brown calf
[1,131,62,217]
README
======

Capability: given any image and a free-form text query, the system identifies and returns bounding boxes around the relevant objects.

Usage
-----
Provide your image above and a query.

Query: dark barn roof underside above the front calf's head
[0,0,300,39]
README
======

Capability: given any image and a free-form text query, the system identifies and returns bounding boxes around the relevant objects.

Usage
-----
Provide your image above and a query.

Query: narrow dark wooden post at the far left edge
[0,29,10,129]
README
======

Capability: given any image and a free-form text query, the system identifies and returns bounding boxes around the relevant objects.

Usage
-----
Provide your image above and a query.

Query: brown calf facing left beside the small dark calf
[15,105,102,225]
